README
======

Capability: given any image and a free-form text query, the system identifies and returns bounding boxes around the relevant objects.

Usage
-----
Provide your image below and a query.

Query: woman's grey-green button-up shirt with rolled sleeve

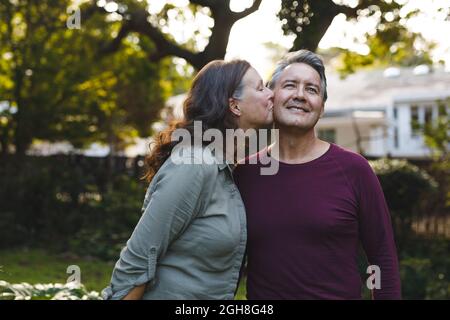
[102,148,247,299]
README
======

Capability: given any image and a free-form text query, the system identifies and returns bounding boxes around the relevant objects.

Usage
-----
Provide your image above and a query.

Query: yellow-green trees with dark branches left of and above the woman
[0,0,261,156]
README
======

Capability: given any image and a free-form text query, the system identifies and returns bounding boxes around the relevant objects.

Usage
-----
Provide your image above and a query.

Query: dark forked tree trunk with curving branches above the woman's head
[82,0,262,70]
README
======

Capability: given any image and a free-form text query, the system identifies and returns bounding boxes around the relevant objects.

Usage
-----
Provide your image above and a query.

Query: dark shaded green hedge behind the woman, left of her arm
[0,157,146,260]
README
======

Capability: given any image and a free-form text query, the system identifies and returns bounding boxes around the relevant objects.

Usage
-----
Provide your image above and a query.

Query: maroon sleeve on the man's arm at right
[358,160,401,300]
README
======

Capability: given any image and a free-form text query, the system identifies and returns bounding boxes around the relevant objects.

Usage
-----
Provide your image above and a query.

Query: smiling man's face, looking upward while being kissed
[273,63,324,131]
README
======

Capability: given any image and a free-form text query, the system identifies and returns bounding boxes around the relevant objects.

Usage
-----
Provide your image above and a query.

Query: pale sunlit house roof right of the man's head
[325,66,450,113]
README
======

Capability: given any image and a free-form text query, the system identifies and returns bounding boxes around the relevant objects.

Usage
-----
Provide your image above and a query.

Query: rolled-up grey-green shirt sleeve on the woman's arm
[102,158,217,300]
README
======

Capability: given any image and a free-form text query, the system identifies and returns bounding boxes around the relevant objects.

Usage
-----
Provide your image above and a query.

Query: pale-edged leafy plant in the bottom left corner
[0,280,101,300]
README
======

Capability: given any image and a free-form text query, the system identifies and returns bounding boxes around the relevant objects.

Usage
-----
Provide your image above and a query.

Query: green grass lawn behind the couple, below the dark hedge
[0,249,245,300]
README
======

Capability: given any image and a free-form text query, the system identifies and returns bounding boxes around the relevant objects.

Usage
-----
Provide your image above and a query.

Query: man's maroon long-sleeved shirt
[234,144,401,299]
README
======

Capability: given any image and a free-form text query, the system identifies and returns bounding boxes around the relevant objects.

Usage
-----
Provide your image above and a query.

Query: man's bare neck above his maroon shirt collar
[270,128,330,164]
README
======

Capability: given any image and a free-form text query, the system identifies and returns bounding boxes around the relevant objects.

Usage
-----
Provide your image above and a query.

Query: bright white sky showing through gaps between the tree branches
[91,0,450,78]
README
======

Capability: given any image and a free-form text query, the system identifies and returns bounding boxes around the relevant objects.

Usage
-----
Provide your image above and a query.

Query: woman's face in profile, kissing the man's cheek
[232,68,273,130]
